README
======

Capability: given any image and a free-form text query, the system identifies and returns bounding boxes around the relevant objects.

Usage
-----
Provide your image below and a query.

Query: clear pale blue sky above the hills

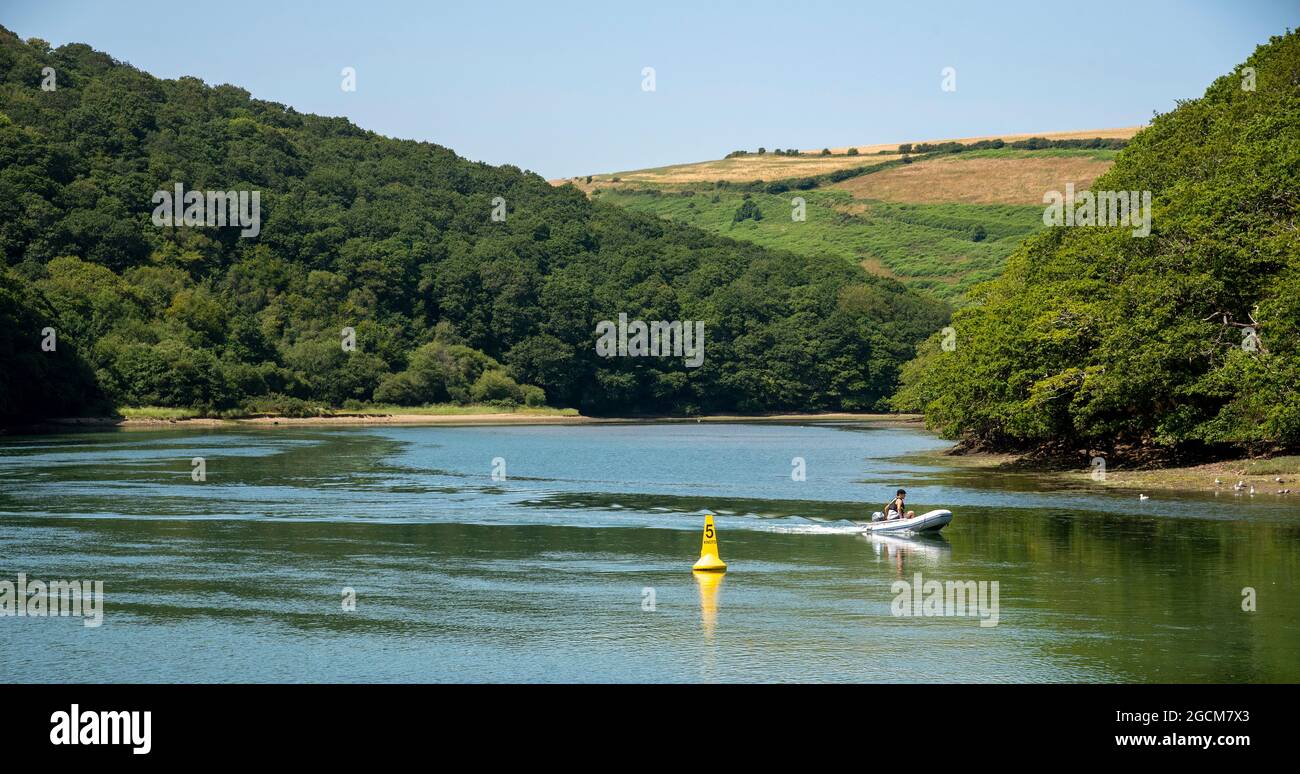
[0,0,1300,177]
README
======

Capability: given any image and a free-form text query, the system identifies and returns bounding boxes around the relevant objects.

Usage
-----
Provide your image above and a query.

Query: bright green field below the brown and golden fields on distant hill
[595,187,1040,302]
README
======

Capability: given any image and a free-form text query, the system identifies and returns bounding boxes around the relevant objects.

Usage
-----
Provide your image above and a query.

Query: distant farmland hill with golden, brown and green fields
[577,129,1136,299]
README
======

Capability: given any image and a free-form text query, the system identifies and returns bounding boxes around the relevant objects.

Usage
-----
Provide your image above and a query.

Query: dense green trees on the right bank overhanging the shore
[896,33,1300,462]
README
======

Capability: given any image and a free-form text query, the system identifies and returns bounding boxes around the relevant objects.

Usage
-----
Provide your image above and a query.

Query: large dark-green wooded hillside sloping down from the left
[0,27,948,421]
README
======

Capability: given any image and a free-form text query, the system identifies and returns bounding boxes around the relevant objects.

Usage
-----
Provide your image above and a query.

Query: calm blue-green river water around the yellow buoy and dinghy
[0,423,1300,683]
